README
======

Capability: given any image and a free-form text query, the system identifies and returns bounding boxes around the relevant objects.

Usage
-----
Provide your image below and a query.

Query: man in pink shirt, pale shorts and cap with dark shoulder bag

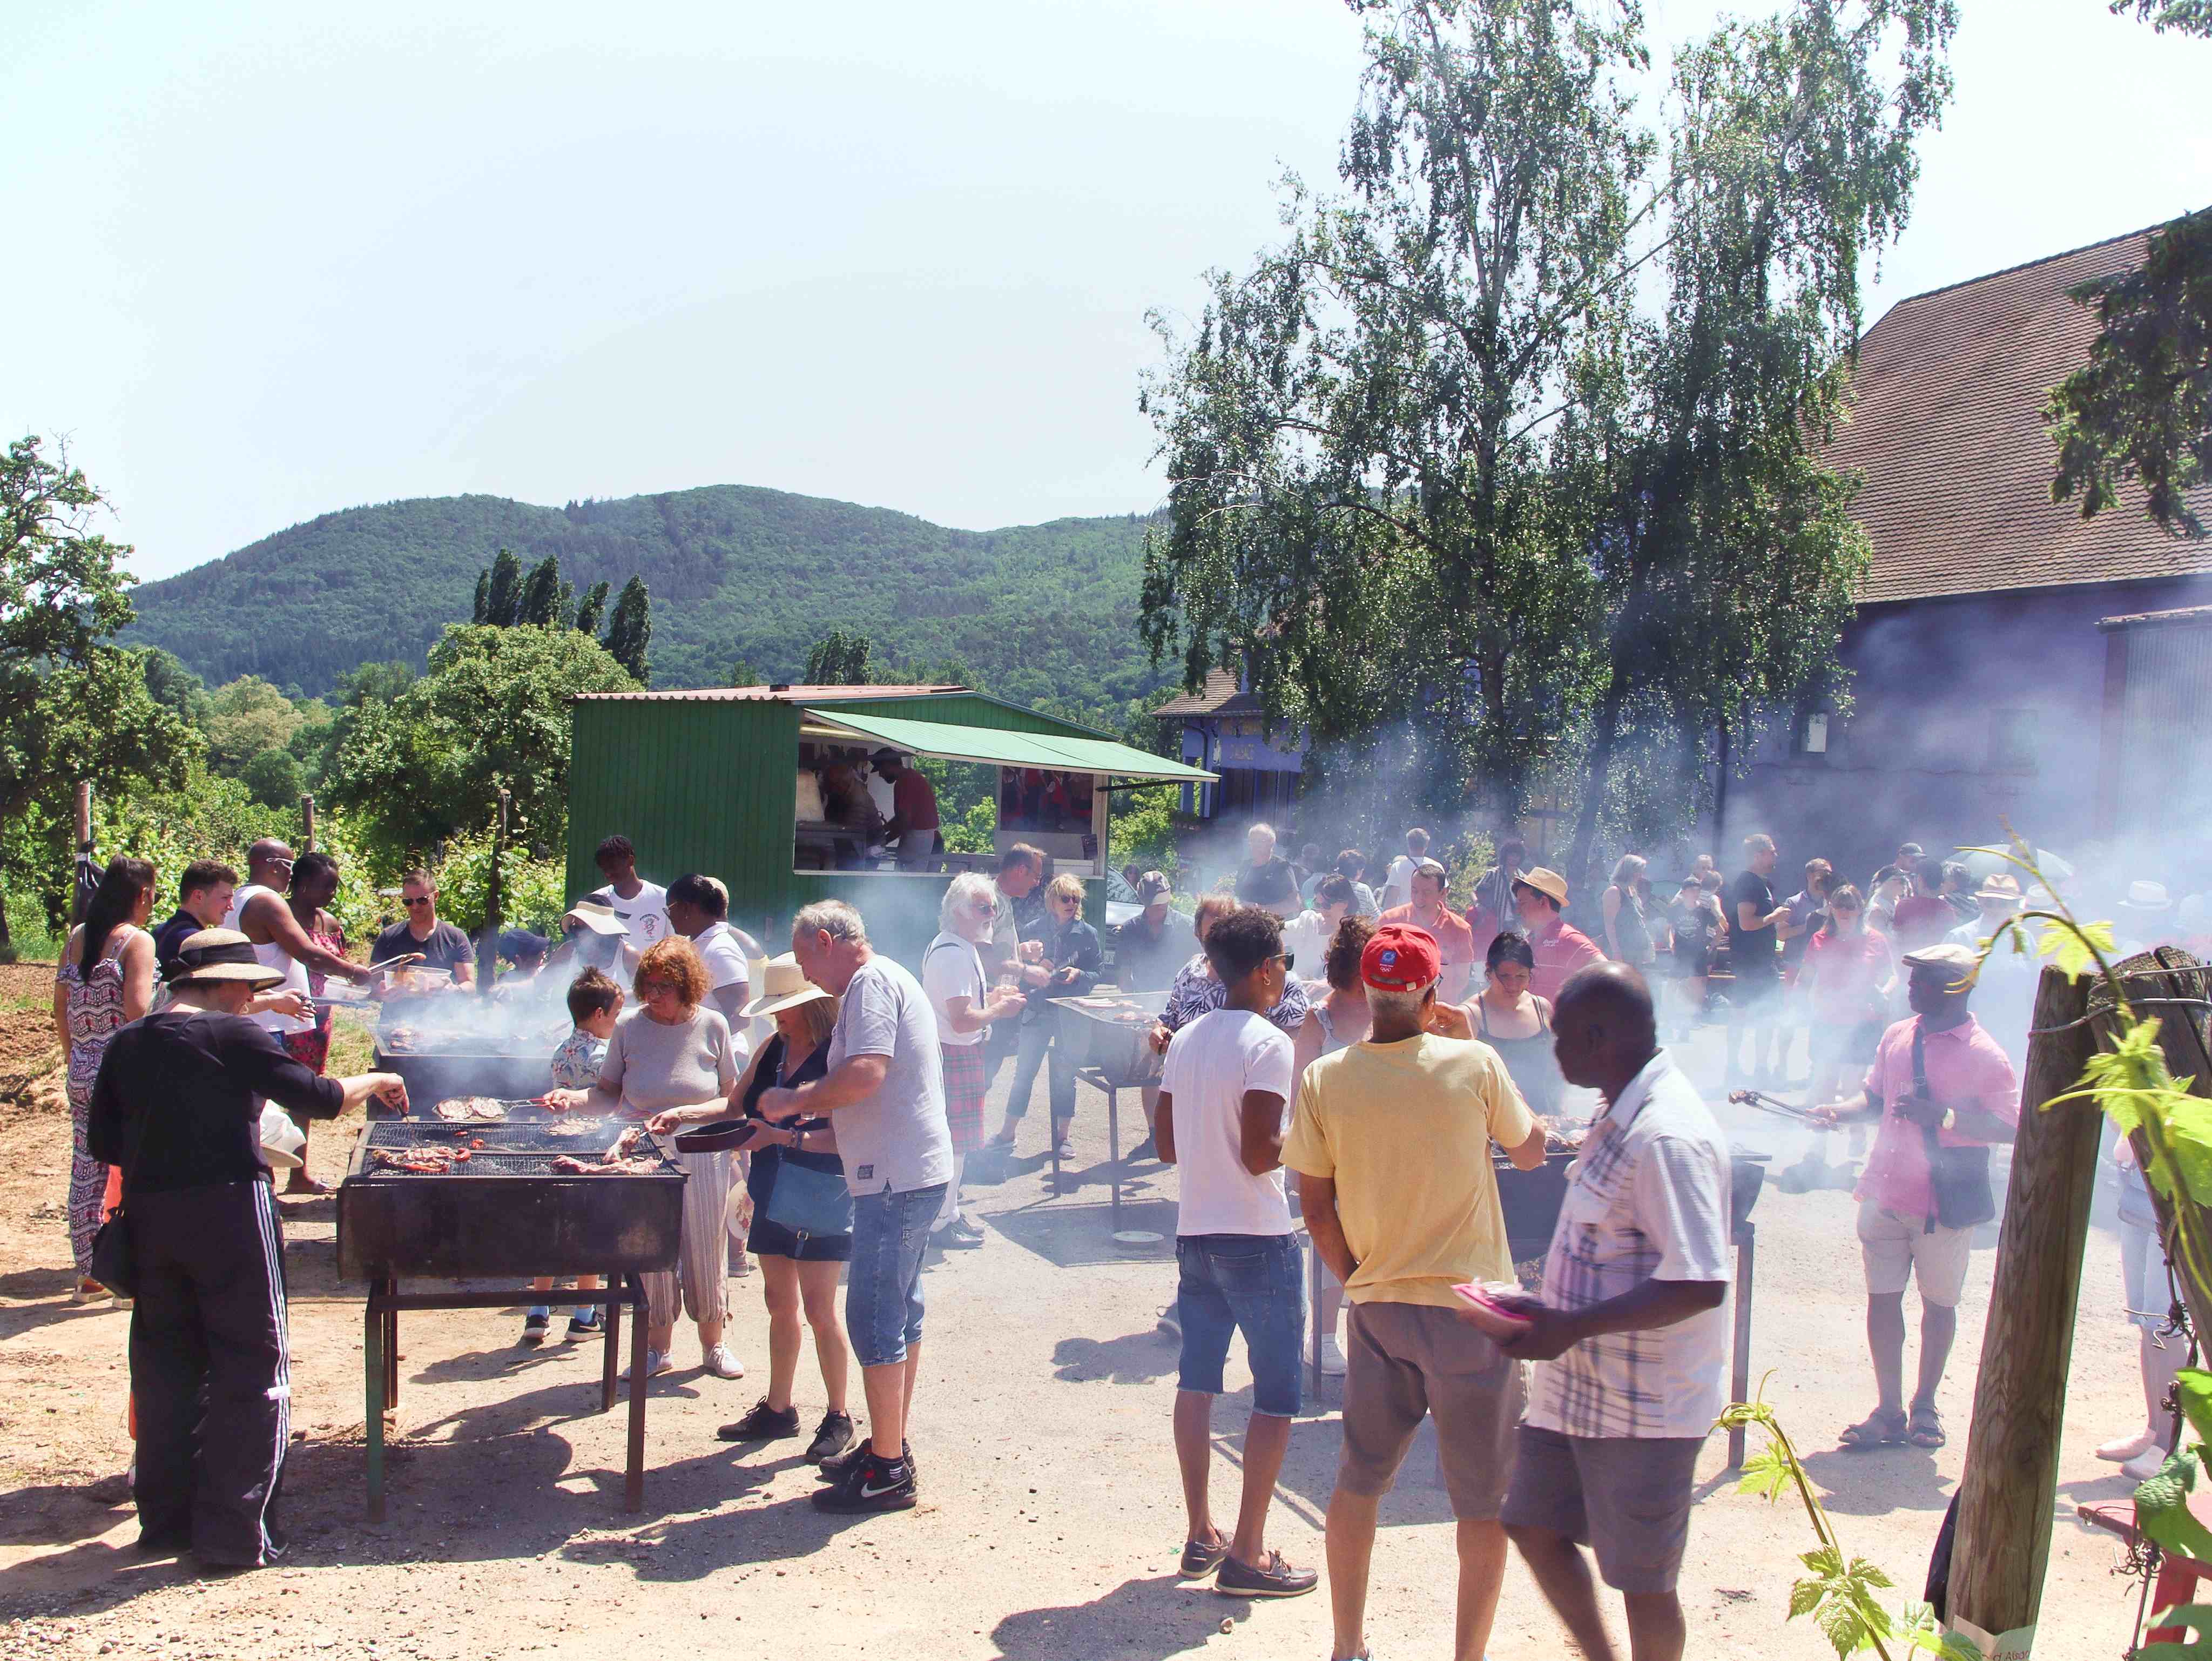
[1818,944,2020,1449]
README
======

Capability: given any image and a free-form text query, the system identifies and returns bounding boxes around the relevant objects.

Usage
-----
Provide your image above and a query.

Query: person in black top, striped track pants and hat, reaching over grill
[89,929,407,1566]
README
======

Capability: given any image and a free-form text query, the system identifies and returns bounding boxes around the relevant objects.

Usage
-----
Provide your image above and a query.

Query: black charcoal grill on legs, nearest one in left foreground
[339,1119,686,1522]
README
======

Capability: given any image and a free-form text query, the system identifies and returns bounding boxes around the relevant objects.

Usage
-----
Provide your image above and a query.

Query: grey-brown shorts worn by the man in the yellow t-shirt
[1336,1303,1522,1522]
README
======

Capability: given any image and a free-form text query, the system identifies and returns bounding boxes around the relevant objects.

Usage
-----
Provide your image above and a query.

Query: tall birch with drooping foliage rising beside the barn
[1142,0,1951,858]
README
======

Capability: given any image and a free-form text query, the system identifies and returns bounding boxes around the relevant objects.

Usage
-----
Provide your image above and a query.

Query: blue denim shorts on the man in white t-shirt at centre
[1175,1234,1305,1418]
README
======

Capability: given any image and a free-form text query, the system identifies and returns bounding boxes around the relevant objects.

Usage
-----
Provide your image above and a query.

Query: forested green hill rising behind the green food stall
[126,485,1172,703]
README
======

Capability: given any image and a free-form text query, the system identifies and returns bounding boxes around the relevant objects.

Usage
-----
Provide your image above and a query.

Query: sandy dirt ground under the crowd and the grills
[0,986,2168,1661]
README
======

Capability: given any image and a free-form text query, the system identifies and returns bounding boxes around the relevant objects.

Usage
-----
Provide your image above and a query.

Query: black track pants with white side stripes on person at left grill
[124,1181,292,1564]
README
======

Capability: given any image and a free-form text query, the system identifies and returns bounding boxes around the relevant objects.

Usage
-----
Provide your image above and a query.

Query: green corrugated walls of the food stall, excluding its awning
[569,695,1104,964]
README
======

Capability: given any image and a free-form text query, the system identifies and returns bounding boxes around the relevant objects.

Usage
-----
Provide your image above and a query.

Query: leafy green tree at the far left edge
[0,436,199,956]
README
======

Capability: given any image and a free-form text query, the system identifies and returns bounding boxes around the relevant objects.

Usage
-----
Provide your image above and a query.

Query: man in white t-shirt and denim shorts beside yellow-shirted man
[1152,907,1318,1597]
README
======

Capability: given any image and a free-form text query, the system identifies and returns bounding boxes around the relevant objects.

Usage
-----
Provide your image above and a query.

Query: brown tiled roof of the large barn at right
[1827,230,2212,604]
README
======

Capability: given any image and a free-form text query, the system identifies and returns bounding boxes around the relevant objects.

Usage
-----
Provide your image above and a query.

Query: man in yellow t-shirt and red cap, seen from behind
[1283,925,1544,1661]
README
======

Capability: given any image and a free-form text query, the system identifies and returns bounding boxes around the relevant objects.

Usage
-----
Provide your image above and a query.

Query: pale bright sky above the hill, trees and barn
[0,0,2212,577]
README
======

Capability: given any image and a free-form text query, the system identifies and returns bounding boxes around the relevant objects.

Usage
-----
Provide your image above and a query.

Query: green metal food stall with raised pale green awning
[569,685,1215,958]
